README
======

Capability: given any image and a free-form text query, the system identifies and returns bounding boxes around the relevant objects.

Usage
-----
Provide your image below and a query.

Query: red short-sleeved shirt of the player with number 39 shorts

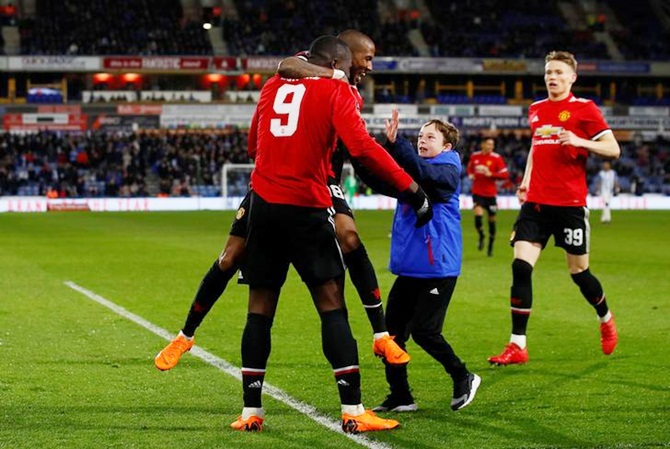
[526,94,612,206]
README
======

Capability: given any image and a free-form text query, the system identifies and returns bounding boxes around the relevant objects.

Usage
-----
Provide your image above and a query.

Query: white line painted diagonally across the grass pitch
[63,281,392,449]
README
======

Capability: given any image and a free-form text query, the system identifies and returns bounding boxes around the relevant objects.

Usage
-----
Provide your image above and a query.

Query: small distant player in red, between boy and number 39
[467,137,509,257]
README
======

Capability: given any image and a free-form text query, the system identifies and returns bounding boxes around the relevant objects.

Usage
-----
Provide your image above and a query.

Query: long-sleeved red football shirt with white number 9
[248,75,412,207]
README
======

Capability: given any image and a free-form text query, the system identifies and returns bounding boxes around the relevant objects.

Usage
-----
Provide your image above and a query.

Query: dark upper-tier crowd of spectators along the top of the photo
[3,0,670,60]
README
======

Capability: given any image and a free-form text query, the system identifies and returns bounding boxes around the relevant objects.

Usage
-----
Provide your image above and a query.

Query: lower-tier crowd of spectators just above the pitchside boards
[0,128,670,198]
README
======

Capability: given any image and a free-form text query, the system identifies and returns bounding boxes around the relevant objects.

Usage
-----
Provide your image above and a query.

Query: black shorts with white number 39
[510,203,591,256]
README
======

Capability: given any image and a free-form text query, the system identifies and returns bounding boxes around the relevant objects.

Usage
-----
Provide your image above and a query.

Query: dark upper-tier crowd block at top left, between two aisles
[19,0,212,55]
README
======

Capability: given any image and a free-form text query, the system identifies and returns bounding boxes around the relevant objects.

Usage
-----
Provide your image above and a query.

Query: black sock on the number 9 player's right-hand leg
[320,309,361,405]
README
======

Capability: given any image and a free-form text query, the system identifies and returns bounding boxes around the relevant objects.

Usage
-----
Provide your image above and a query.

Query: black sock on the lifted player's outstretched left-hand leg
[181,260,238,337]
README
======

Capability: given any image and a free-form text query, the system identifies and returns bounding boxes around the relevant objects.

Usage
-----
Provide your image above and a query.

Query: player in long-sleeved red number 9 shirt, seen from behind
[231,36,432,433]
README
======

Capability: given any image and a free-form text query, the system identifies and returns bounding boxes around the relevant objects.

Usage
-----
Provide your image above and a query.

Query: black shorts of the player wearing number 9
[242,192,344,289]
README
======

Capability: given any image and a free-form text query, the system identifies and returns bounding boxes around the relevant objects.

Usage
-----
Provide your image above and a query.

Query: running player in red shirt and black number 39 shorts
[488,51,621,365]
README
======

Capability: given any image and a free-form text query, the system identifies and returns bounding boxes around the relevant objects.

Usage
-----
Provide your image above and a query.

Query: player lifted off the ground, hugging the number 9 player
[154,30,410,370]
